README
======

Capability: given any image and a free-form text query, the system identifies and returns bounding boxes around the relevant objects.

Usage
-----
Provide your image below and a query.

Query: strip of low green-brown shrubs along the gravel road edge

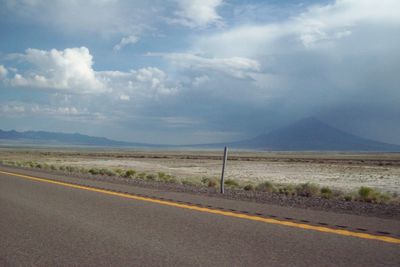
[0,160,400,205]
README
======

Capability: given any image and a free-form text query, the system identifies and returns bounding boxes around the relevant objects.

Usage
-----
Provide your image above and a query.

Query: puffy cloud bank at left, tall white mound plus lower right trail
[0,47,178,101]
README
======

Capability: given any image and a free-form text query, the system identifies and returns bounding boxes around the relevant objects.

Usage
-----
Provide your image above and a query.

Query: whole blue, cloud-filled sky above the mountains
[0,0,400,144]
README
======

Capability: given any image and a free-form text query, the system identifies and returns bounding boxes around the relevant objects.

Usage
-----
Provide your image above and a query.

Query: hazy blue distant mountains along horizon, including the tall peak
[0,118,400,152]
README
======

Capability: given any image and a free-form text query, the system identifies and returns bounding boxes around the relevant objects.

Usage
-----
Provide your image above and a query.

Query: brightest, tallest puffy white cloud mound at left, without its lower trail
[10,47,107,93]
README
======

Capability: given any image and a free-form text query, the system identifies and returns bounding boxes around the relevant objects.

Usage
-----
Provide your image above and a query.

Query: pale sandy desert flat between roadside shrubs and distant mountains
[0,148,400,194]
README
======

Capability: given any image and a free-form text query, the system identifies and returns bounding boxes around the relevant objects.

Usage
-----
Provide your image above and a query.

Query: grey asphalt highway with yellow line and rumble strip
[0,167,400,266]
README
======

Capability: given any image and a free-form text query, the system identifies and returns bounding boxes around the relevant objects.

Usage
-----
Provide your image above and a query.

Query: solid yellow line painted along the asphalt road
[0,171,400,244]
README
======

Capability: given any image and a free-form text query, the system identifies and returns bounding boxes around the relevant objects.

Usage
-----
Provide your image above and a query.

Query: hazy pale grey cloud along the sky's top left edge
[4,0,158,36]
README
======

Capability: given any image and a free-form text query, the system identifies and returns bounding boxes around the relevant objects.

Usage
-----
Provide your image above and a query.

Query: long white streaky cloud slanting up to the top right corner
[194,0,400,57]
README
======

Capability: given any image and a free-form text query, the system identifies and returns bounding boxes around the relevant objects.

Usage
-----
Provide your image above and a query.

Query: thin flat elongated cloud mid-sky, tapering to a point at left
[149,53,261,79]
